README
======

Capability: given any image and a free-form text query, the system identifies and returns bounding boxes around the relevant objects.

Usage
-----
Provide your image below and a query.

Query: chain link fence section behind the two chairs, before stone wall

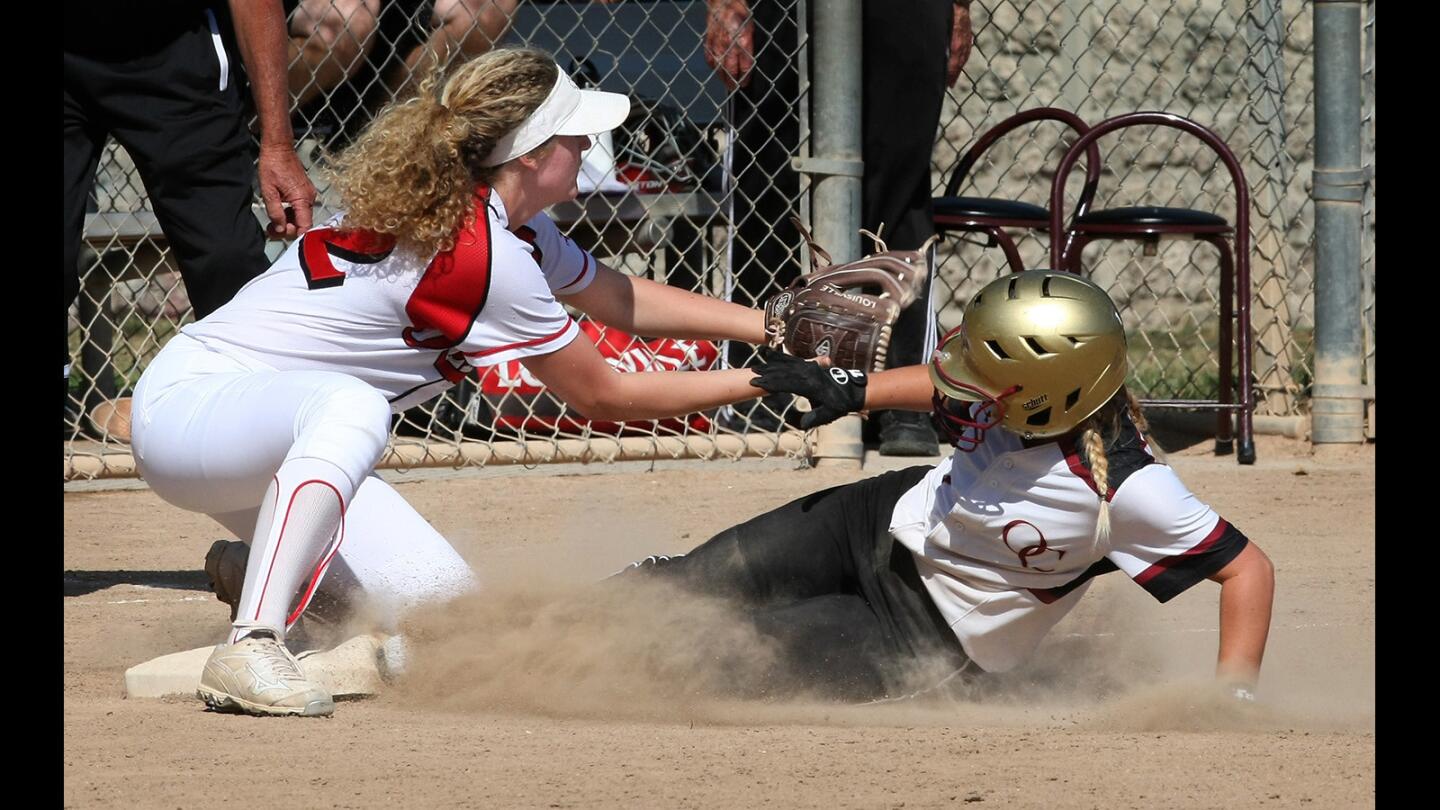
[935,0,1347,415]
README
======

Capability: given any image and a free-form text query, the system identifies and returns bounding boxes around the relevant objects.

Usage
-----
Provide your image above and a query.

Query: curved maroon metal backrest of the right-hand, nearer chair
[1050,111,1250,269]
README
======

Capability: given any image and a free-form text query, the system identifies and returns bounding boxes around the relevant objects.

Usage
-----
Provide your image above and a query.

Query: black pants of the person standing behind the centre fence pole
[730,0,955,368]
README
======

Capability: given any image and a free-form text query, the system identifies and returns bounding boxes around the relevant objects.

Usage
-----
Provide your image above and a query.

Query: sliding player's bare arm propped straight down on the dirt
[1211,542,1274,689]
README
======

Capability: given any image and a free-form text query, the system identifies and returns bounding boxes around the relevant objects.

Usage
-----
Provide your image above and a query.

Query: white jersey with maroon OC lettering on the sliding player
[890,406,1247,672]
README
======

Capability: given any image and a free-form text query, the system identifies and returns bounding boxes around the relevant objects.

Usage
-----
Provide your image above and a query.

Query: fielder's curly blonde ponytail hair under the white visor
[325,48,559,251]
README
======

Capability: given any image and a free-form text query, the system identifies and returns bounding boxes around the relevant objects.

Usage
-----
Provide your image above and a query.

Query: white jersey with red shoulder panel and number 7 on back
[181,189,596,411]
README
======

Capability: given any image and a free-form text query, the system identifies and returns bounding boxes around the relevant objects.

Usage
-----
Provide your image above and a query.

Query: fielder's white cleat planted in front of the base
[196,633,336,718]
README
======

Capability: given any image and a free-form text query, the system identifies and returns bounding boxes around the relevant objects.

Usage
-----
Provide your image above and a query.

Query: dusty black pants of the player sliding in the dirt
[634,467,969,700]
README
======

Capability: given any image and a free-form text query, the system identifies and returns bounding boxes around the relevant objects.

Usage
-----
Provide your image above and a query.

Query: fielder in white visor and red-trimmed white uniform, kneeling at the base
[132,50,765,715]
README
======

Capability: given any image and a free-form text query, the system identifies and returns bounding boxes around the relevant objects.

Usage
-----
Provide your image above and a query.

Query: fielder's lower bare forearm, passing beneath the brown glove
[523,337,762,422]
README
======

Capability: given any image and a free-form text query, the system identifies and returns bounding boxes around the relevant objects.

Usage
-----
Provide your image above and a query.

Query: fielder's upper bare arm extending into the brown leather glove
[560,262,765,343]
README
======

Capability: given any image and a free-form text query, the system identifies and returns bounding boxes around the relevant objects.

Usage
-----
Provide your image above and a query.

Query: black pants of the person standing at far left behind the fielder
[63,4,269,328]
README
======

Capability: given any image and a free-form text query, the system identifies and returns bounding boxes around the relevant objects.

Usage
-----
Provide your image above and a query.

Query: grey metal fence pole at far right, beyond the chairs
[1310,0,1374,444]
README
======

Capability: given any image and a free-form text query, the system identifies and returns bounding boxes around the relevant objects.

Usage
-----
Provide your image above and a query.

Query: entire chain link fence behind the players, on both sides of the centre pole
[65,0,1374,479]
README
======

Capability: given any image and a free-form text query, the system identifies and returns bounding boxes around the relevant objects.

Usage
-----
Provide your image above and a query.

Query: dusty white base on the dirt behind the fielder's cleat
[125,634,384,698]
